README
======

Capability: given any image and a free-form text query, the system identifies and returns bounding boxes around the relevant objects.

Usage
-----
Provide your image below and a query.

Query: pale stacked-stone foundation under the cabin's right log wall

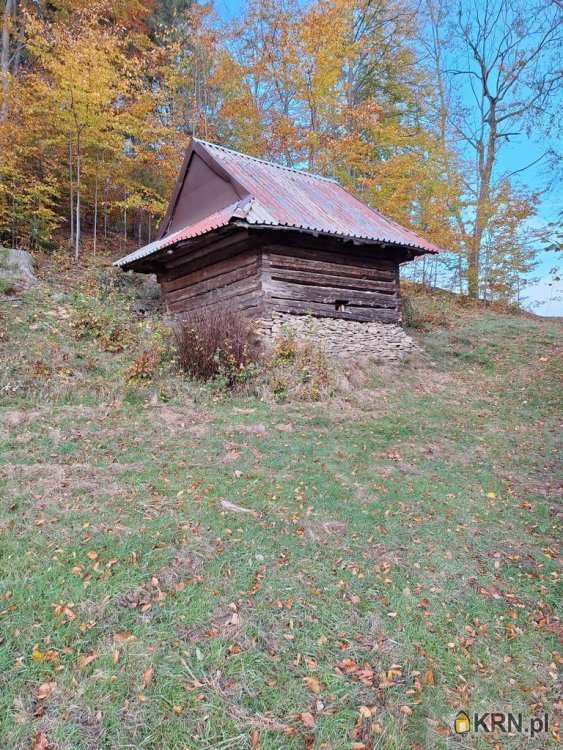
[257,313,417,361]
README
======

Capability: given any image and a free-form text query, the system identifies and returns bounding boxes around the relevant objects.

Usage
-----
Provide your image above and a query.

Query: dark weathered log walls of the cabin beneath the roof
[158,232,400,323]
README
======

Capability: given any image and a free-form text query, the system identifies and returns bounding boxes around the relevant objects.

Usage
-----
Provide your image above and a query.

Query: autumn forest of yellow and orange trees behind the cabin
[0,0,563,302]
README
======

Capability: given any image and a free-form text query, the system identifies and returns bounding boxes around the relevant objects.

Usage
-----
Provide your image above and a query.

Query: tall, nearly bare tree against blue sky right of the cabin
[424,0,563,297]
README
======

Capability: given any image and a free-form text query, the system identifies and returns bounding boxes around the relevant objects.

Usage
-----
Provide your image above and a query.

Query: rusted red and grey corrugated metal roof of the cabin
[116,139,440,266]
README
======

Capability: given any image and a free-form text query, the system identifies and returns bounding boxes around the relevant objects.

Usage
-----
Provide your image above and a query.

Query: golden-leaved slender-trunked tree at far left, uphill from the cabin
[0,0,183,257]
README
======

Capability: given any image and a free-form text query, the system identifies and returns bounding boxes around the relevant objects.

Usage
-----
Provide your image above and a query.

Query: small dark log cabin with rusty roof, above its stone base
[115,138,439,323]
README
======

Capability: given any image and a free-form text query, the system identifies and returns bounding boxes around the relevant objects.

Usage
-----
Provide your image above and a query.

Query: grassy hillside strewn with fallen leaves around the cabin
[0,256,561,750]
